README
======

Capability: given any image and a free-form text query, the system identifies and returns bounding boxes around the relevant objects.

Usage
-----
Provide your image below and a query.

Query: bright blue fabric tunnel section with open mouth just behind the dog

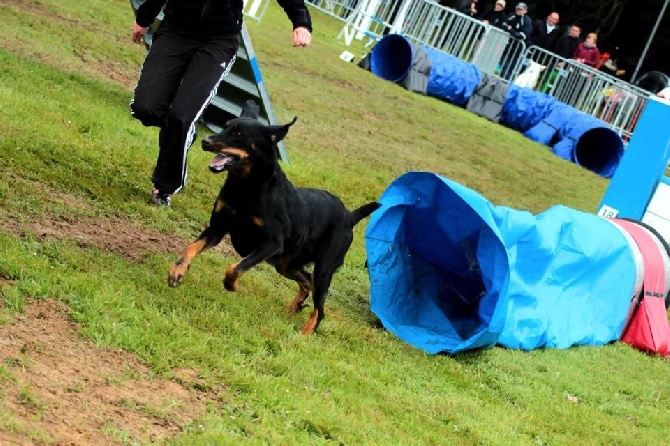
[366,172,639,354]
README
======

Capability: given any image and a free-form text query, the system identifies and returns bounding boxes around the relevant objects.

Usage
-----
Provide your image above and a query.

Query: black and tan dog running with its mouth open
[168,102,379,334]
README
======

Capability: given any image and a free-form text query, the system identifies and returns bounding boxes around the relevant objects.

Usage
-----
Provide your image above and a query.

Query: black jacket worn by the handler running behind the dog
[135,0,312,35]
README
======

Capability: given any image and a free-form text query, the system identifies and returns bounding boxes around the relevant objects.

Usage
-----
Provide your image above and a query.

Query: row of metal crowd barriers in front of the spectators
[318,0,650,141]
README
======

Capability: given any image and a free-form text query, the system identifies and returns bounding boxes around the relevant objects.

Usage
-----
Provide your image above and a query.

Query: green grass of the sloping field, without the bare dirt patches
[0,0,670,445]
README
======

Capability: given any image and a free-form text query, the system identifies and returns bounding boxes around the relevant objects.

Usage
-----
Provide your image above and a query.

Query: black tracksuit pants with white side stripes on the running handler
[130,23,239,194]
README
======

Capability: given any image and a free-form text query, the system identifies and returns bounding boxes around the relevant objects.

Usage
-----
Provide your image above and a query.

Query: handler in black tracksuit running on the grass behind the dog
[130,0,312,206]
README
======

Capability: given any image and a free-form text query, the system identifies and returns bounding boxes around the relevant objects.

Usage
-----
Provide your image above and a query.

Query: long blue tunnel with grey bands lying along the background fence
[369,34,624,178]
